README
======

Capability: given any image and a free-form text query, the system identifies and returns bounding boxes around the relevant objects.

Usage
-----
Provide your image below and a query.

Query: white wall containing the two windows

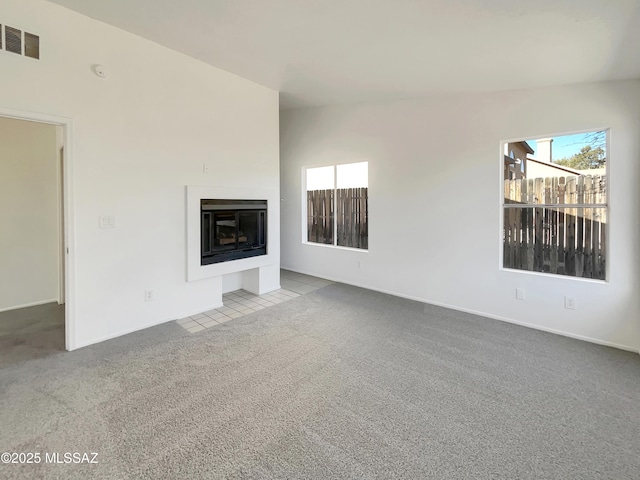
[280,81,640,350]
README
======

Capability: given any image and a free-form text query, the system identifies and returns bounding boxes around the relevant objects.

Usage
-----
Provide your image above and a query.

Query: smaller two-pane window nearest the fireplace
[306,162,369,250]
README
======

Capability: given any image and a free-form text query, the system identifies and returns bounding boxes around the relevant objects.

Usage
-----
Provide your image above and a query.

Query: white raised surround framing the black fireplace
[186,185,280,295]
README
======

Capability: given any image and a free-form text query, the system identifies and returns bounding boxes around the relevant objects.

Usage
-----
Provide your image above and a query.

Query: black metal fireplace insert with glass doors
[200,199,267,265]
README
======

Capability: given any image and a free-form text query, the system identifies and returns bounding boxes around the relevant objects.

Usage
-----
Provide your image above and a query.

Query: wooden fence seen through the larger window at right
[503,175,607,280]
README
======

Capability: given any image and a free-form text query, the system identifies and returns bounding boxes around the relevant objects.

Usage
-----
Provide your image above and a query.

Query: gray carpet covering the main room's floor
[0,284,640,479]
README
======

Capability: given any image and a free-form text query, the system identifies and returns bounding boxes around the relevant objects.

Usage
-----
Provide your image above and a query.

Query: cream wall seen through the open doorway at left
[0,117,59,311]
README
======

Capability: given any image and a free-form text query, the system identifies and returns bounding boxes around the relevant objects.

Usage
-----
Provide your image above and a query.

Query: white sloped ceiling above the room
[51,0,640,108]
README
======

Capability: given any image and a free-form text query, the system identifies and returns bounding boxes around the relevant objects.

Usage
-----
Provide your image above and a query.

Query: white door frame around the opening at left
[0,106,76,351]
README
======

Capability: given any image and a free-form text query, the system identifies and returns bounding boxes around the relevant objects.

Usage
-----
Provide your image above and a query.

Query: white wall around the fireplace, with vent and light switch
[0,0,279,348]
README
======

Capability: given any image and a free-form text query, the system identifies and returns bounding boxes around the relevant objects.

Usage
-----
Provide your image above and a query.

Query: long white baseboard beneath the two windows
[281,265,640,354]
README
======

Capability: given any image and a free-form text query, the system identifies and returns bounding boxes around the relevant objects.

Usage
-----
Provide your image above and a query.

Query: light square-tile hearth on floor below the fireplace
[177,270,333,333]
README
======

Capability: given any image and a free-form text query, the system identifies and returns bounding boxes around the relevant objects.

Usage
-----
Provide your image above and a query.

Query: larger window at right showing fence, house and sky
[502,130,609,280]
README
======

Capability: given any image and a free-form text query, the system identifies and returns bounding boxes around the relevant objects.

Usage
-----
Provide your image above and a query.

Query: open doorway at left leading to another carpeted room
[0,109,73,366]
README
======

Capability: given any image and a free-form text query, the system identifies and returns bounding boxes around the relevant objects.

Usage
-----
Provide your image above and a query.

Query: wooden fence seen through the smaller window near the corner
[307,188,369,249]
